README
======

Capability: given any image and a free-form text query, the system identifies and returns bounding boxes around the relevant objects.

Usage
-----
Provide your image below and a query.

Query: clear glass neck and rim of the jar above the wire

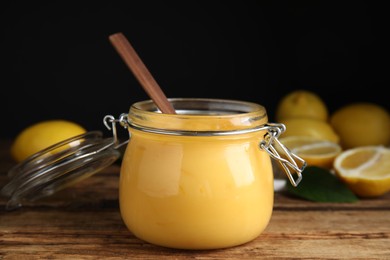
[128,98,268,133]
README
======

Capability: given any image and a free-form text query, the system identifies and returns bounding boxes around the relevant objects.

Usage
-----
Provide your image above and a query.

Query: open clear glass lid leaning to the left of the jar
[1,131,120,210]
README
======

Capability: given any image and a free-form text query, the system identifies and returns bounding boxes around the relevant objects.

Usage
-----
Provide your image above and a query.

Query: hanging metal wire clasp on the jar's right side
[260,123,306,187]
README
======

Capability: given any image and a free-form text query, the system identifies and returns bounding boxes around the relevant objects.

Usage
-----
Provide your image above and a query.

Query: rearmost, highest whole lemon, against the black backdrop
[275,90,329,121]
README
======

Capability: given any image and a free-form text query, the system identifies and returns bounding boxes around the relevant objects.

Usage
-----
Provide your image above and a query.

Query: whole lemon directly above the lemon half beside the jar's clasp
[280,118,339,143]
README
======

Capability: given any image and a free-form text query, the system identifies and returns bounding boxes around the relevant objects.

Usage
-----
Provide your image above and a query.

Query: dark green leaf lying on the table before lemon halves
[286,166,359,203]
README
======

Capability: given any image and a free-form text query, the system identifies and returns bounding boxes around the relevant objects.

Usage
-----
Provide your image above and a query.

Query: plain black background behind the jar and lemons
[0,0,390,138]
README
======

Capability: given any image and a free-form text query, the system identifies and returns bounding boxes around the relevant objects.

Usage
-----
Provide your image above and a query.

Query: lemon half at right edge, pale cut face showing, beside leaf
[333,146,390,197]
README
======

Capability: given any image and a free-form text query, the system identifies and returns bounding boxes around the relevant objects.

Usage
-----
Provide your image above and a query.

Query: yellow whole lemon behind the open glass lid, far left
[11,120,86,162]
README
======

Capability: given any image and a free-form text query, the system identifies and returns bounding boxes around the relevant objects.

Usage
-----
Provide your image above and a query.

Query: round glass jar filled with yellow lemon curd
[119,99,274,249]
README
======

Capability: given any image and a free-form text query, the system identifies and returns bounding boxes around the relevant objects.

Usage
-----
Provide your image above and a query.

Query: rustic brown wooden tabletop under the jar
[0,140,390,259]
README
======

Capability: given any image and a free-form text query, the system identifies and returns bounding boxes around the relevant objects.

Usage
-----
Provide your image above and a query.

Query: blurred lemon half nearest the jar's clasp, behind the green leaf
[279,136,342,169]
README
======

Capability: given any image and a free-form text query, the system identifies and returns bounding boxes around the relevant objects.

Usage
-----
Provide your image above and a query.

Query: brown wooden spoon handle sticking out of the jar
[109,33,176,114]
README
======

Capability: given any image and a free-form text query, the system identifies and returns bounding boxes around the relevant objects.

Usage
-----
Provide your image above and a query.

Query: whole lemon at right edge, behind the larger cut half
[330,102,390,149]
